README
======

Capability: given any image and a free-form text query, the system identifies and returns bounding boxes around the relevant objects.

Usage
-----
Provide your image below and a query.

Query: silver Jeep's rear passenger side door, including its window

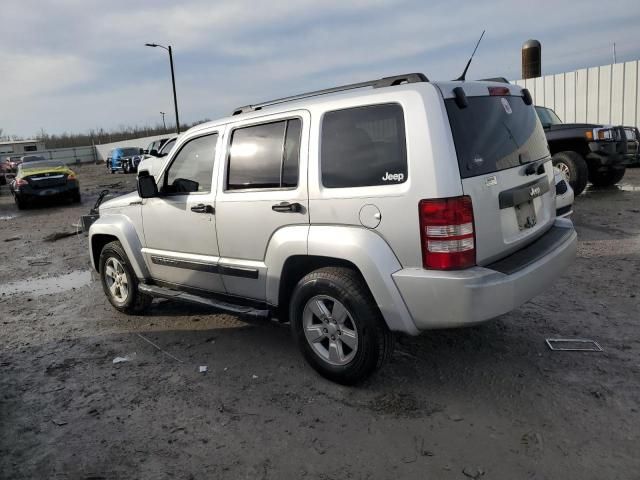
[216,111,310,300]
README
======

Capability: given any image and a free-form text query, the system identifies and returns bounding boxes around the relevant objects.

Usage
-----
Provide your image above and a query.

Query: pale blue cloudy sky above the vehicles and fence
[0,0,640,136]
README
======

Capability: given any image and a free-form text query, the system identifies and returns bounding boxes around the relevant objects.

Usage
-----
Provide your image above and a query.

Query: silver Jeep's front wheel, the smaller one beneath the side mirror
[99,241,153,314]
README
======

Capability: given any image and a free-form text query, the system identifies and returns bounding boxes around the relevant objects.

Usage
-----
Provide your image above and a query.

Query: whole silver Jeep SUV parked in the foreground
[89,74,576,384]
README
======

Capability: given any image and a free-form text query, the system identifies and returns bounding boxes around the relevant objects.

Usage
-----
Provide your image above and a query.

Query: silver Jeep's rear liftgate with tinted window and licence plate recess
[443,84,555,265]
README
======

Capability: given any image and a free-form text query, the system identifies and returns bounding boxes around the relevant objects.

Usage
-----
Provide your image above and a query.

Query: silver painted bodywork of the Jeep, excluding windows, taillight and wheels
[89,82,575,335]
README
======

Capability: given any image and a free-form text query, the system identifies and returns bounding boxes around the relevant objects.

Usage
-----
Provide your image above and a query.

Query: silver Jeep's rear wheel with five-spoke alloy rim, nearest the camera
[289,267,393,385]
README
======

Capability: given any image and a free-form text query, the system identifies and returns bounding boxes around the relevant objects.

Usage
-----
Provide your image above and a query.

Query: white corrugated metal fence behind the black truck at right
[516,60,640,127]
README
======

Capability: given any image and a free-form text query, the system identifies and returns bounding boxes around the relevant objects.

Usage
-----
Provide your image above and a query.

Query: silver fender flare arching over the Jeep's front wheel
[89,214,150,279]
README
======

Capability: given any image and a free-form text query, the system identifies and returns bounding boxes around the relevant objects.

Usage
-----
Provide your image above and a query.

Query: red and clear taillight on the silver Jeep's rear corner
[418,196,476,270]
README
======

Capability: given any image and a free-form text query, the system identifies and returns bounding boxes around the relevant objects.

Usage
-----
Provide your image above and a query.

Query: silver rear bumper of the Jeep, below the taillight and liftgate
[393,219,577,330]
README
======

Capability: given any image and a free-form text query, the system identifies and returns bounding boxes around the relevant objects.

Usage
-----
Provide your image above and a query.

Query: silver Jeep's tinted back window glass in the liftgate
[445,96,549,178]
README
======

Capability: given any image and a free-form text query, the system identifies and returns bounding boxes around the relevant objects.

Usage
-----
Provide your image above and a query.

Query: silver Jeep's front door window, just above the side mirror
[163,133,218,194]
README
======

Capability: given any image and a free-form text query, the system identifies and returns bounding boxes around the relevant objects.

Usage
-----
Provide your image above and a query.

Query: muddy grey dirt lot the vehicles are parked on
[0,165,640,480]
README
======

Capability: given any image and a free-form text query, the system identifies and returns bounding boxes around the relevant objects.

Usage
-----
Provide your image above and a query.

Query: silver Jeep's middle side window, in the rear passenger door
[227,118,302,190]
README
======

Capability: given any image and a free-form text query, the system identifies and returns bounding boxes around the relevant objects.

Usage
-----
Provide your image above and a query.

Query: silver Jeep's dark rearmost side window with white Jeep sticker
[320,104,407,188]
